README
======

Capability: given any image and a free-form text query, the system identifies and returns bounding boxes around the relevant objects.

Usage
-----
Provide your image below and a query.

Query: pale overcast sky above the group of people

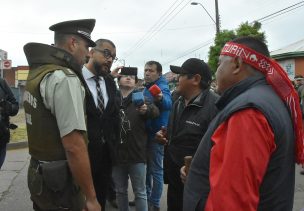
[0,0,304,77]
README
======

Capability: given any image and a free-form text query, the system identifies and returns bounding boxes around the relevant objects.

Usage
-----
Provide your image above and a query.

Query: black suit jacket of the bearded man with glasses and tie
[82,75,120,166]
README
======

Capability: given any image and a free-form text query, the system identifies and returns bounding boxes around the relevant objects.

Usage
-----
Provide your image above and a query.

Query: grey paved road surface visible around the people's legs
[0,149,304,211]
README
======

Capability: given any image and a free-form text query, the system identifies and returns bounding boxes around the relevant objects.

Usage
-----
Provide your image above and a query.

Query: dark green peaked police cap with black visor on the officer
[49,19,96,47]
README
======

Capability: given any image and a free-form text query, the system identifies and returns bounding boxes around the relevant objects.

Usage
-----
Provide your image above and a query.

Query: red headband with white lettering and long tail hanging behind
[221,42,304,164]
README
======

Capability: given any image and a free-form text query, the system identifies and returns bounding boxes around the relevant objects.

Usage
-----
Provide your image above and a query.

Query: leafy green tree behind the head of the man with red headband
[208,21,266,75]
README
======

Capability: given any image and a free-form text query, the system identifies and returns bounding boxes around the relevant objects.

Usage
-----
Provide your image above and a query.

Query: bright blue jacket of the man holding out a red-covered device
[143,76,172,140]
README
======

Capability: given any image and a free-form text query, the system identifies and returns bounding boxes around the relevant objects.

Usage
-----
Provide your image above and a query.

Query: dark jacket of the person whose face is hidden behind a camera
[115,91,159,165]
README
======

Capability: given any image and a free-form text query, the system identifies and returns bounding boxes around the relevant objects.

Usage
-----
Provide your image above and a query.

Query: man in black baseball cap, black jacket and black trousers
[156,58,218,211]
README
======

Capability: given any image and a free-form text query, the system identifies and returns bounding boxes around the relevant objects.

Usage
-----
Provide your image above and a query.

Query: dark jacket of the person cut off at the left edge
[0,78,19,148]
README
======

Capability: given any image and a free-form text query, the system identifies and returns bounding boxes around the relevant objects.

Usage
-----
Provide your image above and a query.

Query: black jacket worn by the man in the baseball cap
[166,90,219,168]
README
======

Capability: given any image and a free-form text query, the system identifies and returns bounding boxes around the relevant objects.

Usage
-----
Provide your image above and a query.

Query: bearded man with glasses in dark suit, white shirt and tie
[82,39,120,209]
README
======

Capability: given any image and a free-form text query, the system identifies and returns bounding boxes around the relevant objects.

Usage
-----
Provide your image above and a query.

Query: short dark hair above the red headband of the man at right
[232,36,270,57]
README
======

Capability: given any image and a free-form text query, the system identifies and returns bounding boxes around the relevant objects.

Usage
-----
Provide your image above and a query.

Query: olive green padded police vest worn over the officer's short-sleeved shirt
[24,43,86,161]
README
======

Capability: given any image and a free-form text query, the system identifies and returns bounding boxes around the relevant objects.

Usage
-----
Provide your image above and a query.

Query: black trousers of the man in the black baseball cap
[166,154,184,211]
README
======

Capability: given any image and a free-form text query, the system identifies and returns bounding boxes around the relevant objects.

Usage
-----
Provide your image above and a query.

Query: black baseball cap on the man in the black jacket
[170,58,212,83]
